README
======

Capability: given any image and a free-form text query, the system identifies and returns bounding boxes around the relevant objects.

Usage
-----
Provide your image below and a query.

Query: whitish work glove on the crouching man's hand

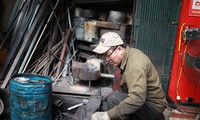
[90,112,110,120]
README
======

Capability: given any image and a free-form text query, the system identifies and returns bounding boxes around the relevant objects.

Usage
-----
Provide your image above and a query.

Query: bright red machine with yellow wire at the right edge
[168,0,200,103]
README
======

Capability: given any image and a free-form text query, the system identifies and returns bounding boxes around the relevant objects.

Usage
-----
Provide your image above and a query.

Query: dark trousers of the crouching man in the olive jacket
[103,92,164,120]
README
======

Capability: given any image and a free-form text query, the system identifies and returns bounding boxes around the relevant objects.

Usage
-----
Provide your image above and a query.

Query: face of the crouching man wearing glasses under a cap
[103,46,123,66]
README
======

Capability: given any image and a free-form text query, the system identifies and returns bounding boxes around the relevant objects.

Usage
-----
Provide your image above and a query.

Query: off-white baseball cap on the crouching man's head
[93,32,124,54]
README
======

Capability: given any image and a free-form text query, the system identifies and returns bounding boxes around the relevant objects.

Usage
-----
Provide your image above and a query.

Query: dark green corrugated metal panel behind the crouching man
[133,0,180,91]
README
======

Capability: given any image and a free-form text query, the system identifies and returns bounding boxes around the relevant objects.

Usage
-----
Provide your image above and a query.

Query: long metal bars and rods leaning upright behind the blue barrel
[0,0,76,88]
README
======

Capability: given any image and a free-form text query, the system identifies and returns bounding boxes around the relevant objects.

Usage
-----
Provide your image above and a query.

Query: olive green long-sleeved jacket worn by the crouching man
[107,47,167,119]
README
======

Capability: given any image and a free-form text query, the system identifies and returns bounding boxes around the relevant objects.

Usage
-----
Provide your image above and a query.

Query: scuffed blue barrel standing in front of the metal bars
[9,74,52,120]
